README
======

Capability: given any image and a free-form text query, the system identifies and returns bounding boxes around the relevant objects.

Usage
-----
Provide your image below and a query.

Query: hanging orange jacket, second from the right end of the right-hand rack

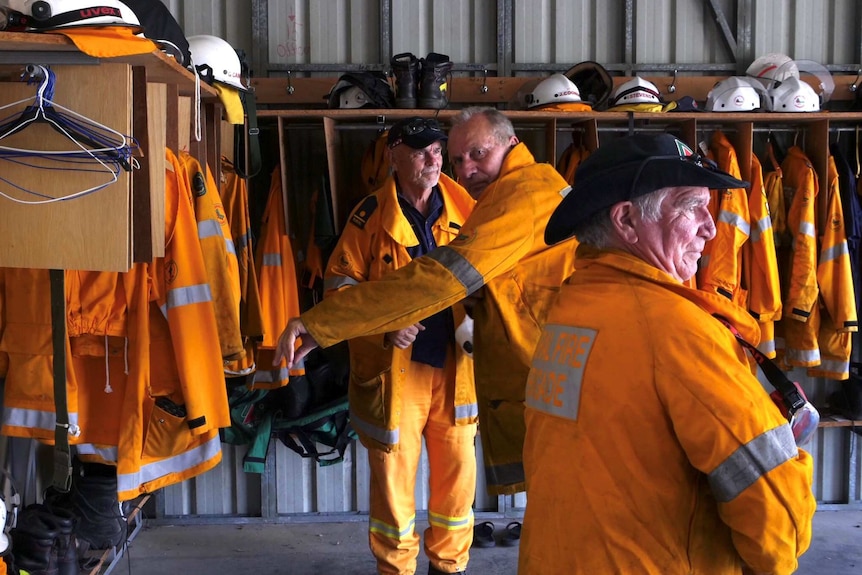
[776,146,820,367]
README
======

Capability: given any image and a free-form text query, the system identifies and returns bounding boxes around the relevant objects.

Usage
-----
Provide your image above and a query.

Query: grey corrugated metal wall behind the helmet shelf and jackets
[154,0,862,521]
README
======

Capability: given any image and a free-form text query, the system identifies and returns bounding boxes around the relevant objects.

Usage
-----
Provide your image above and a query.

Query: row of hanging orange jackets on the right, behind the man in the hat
[557,130,862,380]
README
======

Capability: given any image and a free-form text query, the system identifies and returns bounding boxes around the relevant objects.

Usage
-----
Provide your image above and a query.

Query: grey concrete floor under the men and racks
[111,510,862,575]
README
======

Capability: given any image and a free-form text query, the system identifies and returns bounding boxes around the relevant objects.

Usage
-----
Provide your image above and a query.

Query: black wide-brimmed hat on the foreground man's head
[545,134,749,245]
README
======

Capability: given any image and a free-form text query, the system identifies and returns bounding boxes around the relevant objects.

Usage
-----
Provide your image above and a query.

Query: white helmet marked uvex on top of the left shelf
[6,0,141,30]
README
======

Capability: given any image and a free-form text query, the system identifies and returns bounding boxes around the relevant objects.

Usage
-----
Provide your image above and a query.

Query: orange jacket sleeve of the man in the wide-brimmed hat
[655,321,816,575]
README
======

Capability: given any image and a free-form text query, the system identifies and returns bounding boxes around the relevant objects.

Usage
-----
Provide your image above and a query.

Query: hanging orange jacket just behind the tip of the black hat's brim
[697,130,751,305]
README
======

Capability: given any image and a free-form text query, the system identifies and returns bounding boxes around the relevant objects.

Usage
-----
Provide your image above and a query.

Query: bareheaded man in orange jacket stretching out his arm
[276,108,574,495]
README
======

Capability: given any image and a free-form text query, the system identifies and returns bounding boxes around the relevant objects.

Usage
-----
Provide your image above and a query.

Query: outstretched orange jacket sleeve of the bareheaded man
[302,176,545,347]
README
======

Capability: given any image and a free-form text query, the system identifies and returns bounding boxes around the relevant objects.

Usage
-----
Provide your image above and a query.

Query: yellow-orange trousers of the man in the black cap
[368,361,476,575]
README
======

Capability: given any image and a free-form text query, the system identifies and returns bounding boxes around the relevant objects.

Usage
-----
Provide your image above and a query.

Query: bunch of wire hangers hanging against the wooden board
[0,65,138,204]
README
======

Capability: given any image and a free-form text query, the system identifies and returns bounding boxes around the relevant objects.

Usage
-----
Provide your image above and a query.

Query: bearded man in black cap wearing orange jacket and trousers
[324,117,478,575]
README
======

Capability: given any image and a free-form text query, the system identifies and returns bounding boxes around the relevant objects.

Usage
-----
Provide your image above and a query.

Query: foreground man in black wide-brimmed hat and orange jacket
[519,134,815,575]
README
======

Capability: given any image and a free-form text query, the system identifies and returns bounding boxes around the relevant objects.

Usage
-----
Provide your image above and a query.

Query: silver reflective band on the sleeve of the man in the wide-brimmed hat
[708,423,798,503]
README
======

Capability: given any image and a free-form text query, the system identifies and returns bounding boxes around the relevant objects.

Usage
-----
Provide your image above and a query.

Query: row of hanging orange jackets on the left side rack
[0,150,304,501]
